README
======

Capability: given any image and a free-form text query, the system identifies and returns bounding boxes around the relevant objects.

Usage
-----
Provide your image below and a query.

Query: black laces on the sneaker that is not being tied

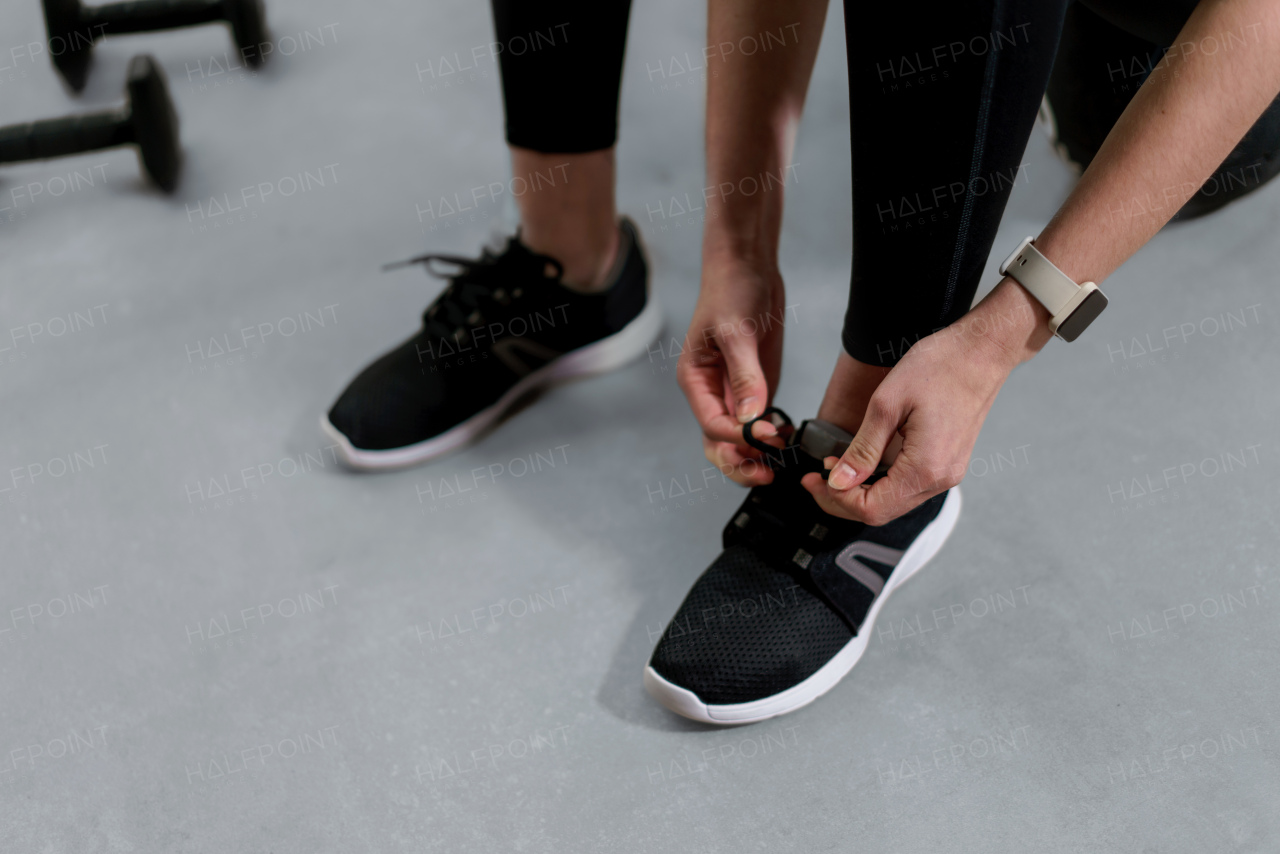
[383,238,564,343]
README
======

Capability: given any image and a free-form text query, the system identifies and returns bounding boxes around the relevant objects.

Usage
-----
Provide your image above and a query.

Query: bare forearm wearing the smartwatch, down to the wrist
[979,0,1280,362]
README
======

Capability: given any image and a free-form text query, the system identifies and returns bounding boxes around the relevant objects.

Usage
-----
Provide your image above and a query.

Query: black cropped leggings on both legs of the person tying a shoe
[493,0,1197,365]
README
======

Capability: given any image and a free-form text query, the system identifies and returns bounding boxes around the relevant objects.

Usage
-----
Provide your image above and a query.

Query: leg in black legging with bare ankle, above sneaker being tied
[819,0,1066,431]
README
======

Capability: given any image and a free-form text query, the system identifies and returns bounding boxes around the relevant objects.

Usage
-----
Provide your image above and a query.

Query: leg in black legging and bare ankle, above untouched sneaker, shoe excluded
[493,0,631,291]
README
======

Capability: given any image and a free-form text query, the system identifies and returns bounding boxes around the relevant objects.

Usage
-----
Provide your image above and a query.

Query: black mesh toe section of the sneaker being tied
[650,545,854,704]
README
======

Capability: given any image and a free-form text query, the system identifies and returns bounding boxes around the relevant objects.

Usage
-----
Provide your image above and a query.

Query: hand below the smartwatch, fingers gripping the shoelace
[801,303,1018,525]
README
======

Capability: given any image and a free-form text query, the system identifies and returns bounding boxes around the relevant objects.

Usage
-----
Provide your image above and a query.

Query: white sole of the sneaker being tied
[644,487,960,726]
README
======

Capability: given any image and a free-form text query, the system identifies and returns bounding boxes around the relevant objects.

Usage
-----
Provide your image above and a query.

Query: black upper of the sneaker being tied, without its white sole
[649,421,946,705]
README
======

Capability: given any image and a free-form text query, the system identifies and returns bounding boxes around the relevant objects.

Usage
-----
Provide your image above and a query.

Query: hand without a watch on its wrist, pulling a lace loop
[676,253,786,487]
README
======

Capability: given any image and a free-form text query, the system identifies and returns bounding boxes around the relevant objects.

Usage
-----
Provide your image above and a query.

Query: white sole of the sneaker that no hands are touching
[320,293,662,471]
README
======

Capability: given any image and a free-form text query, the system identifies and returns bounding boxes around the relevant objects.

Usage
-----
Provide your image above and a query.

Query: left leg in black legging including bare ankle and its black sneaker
[321,0,662,468]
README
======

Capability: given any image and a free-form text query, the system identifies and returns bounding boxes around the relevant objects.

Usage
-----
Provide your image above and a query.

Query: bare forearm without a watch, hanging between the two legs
[703,0,827,266]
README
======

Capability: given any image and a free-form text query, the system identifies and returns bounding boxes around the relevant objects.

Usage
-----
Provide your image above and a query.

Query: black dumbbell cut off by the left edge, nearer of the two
[0,55,182,192]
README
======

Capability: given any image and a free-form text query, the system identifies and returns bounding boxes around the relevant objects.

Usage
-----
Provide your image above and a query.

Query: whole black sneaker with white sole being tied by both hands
[644,410,960,723]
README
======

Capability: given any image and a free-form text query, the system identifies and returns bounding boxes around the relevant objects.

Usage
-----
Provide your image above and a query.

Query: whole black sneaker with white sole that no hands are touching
[320,213,662,469]
